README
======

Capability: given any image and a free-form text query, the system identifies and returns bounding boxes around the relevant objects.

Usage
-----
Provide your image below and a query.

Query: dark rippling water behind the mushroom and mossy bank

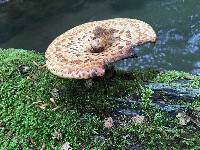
[0,0,200,74]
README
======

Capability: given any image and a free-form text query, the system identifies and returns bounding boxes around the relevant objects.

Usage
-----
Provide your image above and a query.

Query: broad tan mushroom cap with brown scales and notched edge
[45,18,156,79]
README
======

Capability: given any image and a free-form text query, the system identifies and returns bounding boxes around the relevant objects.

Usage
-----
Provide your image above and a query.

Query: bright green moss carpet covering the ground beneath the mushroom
[0,49,200,150]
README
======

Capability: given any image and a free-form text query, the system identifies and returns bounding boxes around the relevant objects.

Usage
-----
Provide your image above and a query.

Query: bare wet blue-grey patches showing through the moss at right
[114,80,200,117]
